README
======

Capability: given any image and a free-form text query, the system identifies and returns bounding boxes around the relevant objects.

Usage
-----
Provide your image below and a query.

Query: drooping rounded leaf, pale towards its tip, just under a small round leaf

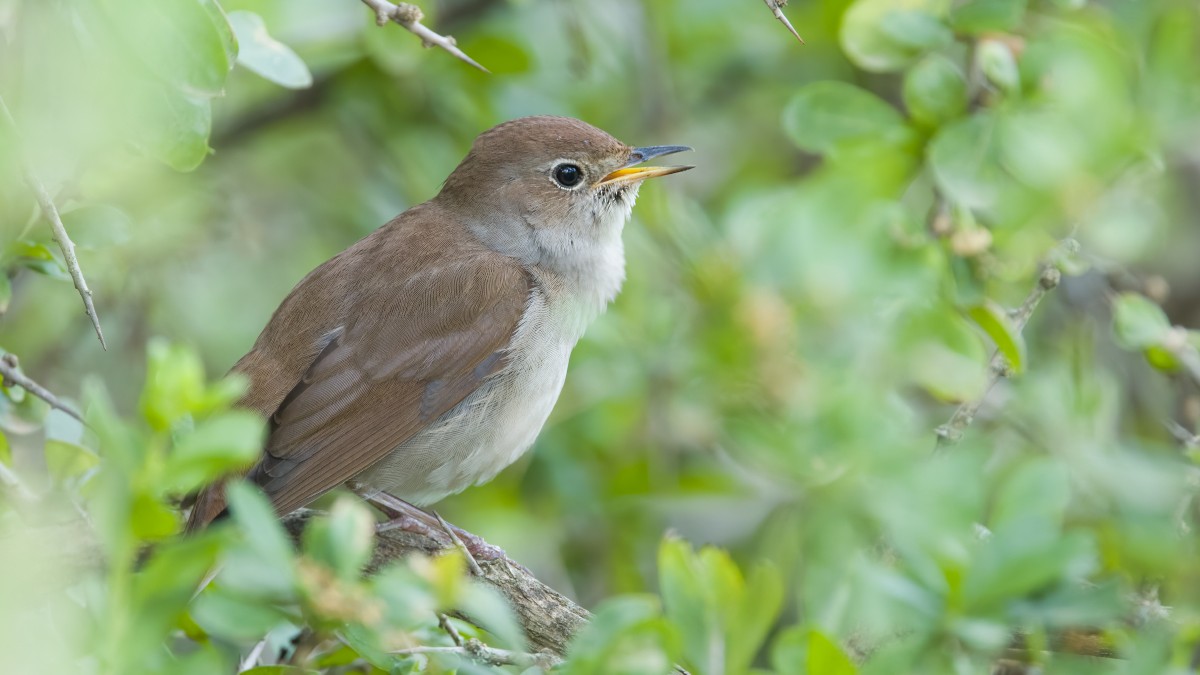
[929,112,1008,209]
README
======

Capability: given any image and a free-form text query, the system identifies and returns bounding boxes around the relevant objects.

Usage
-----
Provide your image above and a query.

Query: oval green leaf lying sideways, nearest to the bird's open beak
[784,82,907,153]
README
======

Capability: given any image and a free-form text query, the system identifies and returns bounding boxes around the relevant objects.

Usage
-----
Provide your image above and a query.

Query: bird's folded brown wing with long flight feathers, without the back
[250,261,529,513]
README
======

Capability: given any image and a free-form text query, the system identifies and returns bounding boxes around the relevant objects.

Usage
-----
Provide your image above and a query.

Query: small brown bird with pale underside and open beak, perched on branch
[187,117,691,530]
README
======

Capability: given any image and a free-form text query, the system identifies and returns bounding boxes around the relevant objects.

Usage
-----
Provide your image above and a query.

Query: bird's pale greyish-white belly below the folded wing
[361,290,578,506]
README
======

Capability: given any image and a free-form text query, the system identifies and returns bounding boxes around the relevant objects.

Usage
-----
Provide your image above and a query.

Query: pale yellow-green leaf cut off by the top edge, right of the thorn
[840,0,952,72]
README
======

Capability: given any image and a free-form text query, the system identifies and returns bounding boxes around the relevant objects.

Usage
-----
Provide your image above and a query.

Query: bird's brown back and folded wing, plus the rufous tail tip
[187,203,529,530]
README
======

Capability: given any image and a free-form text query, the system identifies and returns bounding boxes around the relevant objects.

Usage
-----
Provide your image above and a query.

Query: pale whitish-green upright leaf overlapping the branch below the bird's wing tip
[304,496,374,581]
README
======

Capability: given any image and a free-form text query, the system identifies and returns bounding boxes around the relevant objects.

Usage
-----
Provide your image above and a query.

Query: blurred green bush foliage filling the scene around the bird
[0,0,1200,675]
